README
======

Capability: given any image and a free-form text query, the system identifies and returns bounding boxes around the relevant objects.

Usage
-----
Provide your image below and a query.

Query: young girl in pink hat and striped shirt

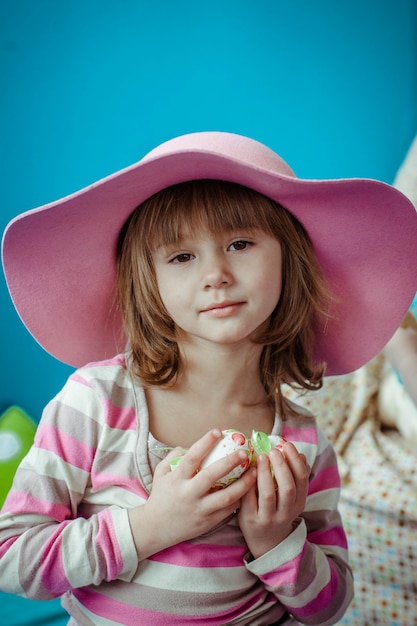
[0,133,417,626]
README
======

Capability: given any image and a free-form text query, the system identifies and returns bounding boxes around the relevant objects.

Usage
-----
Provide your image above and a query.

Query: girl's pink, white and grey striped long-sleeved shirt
[0,355,352,626]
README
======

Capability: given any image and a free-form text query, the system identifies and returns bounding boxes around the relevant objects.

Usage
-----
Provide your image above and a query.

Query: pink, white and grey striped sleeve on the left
[0,364,138,599]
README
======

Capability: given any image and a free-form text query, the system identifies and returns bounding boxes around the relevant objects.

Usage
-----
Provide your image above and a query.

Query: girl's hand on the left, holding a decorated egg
[129,430,256,560]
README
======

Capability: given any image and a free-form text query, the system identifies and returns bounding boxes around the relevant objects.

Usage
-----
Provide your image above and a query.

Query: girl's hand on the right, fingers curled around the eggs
[238,443,310,558]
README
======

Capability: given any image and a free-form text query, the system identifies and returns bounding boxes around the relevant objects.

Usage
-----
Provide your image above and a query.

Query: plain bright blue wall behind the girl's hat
[0,0,417,419]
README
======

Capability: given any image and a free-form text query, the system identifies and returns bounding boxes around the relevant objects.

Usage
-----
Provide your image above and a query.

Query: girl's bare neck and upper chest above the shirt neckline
[147,338,275,447]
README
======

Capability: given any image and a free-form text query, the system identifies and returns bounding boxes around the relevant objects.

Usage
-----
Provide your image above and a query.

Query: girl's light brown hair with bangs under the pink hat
[117,180,331,415]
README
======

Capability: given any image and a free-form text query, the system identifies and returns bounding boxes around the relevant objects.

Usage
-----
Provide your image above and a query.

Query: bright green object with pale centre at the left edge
[0,406,36,507]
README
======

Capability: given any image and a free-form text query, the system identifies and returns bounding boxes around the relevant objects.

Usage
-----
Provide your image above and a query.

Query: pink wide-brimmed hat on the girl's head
[3,132,417,375]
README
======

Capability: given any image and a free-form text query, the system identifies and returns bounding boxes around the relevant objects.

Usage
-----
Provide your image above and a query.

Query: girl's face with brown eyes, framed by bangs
[153,227,282,344]
